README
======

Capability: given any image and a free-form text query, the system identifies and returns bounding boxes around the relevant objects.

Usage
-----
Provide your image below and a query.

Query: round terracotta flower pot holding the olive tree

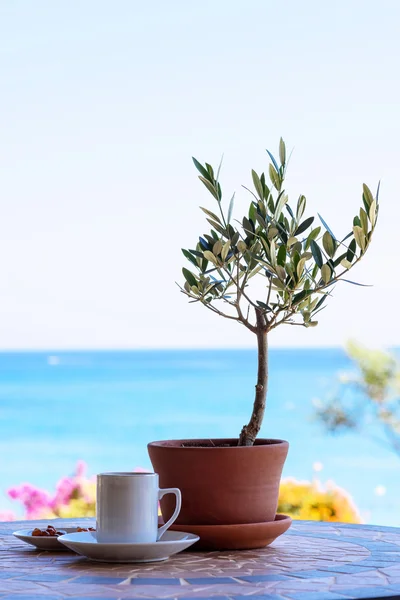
[148,439,289,525]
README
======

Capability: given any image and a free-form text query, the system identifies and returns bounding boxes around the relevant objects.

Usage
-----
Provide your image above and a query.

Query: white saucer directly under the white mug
[58,531,200,563]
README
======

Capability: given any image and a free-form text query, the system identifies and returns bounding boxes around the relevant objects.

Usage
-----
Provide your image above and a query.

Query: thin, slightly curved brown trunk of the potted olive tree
[238,309,268,446]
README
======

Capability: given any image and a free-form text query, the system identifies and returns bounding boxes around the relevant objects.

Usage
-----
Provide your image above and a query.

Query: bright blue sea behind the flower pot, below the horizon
[0,349,400,525]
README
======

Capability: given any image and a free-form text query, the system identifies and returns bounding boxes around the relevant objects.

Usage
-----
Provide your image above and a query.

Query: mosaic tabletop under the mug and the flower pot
[0,519,400,600]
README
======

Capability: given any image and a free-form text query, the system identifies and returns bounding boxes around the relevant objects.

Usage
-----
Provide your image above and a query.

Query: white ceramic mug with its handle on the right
[96,473,182,544]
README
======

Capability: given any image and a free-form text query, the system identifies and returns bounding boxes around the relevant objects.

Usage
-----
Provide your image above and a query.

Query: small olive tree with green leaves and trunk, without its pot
[179,139,379,446]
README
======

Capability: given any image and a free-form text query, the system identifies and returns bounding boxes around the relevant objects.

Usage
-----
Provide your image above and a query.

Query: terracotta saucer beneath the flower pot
[170,514,292,550]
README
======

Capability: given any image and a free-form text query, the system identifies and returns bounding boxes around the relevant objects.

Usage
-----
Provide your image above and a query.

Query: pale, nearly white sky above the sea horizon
[0,0,400,350]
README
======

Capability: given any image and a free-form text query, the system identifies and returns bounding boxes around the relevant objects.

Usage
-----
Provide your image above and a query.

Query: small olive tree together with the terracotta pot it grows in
[149,139,379,547]
